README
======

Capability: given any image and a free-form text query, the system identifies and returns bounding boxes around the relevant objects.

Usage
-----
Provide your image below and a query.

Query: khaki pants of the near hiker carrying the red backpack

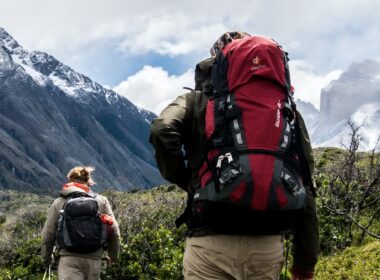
[183,235,284,280]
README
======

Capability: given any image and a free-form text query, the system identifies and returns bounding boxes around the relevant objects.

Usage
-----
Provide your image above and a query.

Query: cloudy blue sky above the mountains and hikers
[0,0,380,113]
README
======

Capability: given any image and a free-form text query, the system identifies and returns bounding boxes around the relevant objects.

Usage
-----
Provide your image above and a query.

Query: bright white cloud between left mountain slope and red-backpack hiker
[113,66,194,114]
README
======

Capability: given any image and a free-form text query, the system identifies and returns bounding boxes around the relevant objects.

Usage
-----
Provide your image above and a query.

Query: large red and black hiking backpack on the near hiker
[193,36,306,219]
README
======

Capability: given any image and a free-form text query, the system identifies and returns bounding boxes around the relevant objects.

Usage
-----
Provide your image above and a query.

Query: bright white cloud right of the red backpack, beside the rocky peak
[289,60,342,109]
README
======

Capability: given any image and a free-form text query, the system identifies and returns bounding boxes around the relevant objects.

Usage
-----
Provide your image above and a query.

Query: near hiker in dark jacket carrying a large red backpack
[150,32,319,279]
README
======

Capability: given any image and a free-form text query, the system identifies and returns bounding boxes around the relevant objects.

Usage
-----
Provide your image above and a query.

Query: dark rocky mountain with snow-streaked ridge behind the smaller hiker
[0,28,162,190]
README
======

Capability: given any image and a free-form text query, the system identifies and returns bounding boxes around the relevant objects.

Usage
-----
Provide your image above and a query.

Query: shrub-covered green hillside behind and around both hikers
[0,145,380,280]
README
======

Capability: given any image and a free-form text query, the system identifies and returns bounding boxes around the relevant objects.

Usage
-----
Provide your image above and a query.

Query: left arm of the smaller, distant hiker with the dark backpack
[41,201,59,265]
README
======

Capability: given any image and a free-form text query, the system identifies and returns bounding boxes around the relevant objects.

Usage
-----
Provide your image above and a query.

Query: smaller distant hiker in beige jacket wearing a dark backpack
[41,166,120,280]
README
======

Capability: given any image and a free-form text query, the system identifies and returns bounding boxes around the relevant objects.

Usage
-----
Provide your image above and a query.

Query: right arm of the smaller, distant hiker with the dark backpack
[104,197,120,263]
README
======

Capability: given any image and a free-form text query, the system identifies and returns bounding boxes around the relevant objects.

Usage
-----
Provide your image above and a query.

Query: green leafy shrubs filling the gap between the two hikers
[102,186,185,280]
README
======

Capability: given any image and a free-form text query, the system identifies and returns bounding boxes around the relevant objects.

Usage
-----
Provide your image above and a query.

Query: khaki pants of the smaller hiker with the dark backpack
[58,256,102,280]
